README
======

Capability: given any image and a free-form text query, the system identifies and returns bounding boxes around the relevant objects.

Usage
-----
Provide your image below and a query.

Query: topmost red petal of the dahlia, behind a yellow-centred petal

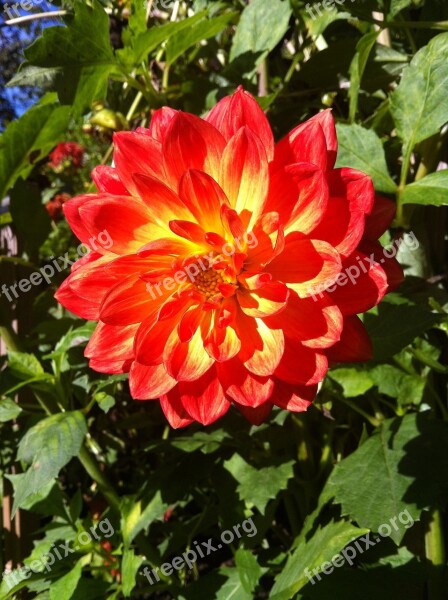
[205,87,274,161]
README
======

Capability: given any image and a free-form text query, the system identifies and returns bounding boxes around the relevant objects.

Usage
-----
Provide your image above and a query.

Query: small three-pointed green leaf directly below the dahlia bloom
[224,454,294,513]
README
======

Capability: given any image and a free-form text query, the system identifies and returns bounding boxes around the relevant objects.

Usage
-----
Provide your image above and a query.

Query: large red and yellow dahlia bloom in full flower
[56,88,401,427]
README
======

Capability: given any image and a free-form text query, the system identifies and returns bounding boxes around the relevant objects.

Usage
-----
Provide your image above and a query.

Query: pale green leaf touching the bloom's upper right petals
[336,123,397,193]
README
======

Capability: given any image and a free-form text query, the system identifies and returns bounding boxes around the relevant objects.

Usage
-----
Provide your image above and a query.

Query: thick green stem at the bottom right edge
[425,508,446,600]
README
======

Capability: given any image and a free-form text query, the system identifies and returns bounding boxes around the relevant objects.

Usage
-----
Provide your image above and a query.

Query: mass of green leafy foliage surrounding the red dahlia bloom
[0,0,448,600]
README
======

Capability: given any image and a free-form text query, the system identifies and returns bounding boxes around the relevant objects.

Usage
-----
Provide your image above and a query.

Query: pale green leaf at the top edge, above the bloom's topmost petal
[230,0,292,72]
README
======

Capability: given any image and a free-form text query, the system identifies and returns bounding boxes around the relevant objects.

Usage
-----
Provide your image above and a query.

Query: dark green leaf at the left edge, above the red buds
[0,104,70,198]
